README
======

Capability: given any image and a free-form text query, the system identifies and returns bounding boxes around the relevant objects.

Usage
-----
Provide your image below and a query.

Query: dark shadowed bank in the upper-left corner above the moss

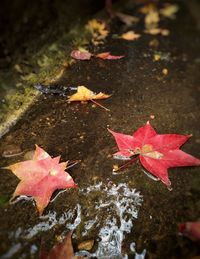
[0,0,104,69]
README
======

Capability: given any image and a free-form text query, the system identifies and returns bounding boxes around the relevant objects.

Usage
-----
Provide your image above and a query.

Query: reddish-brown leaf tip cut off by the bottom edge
[39,232,87,259]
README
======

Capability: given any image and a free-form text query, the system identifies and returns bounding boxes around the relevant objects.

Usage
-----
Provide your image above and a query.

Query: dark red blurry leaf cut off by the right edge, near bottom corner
[178,221,200,242]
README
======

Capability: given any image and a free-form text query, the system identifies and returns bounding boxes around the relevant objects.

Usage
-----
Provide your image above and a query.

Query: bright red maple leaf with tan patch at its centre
[109,122,200,189]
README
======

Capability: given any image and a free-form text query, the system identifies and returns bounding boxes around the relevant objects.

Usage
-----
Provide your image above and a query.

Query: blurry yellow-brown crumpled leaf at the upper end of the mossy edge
[86,19,109,45]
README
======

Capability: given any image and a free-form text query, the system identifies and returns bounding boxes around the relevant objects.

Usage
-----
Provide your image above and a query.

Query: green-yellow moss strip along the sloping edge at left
[0,21,93,137]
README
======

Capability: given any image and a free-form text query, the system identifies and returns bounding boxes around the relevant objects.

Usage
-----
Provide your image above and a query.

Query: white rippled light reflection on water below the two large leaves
[4,183,145,259]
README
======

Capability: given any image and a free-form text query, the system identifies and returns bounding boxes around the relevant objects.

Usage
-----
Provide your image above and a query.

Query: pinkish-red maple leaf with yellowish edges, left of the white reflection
[6,145,76,215]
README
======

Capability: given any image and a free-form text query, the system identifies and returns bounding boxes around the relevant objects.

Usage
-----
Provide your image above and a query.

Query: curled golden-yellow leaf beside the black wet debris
[68,86,111,102]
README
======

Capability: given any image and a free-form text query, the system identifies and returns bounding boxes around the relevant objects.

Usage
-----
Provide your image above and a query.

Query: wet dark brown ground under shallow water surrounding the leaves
[0,0,200,258]
